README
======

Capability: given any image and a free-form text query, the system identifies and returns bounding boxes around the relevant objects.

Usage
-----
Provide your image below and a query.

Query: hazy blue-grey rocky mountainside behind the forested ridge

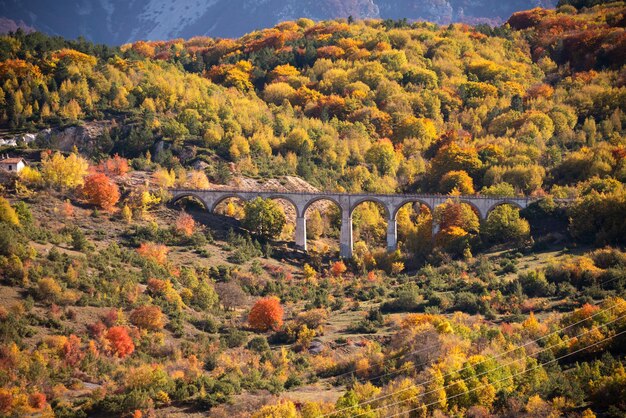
[0,0,557,45]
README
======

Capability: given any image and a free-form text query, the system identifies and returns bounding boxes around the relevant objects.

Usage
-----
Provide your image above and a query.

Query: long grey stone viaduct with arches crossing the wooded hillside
[170,189,537,258]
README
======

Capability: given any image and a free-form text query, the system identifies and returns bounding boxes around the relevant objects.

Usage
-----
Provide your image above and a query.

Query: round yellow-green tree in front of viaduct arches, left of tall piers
[242,197,286,239]
